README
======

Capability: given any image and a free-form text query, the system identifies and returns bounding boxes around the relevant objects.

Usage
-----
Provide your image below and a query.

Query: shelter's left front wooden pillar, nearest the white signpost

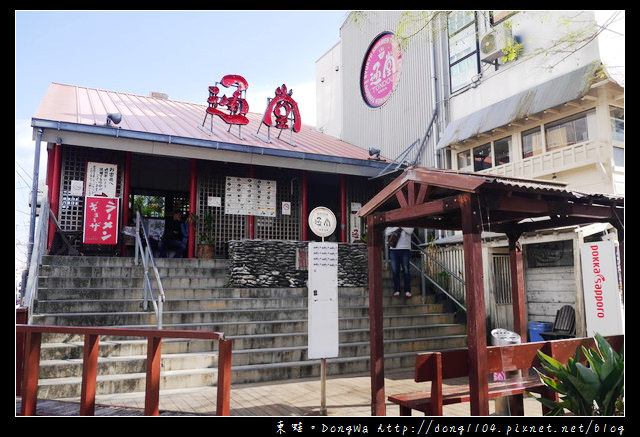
[367,215,387,416]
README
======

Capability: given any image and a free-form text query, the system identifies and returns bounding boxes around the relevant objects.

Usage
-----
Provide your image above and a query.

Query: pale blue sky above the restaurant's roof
[15,10,348,282]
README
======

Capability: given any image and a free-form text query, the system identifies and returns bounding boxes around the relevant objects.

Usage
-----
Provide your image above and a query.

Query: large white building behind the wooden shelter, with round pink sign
[316,11,624,335]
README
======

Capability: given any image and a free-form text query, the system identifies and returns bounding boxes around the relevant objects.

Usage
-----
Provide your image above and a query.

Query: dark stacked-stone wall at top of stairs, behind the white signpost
[229,240,369,288]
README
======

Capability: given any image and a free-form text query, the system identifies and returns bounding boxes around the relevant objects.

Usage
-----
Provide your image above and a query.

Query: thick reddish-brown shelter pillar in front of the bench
[460,194,489,416]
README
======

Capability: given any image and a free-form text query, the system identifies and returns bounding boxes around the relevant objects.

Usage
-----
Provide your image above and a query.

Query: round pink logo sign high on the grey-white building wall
[360,32,402,108]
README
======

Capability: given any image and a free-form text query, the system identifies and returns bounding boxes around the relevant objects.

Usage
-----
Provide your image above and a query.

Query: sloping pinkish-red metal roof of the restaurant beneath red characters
[34,83,378,162]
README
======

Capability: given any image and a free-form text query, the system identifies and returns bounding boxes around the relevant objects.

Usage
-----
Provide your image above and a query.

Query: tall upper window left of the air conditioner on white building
[448,11,480,91]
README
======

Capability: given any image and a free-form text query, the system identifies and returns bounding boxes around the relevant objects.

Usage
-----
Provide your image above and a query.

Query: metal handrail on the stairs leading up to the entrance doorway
[135,210,165,329]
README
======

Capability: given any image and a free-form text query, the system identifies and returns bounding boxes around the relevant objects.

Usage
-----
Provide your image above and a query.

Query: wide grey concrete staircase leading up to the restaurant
[32,256,466,399]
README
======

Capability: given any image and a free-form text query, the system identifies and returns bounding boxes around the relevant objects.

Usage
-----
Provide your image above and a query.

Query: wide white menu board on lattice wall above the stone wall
[224,176,276,217]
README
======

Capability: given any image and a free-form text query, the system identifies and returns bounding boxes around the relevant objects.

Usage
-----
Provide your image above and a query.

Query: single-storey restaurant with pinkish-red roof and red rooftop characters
[32,75,386,257]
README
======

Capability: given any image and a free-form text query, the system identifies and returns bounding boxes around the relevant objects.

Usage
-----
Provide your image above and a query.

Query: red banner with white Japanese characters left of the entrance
[82,196,119,244]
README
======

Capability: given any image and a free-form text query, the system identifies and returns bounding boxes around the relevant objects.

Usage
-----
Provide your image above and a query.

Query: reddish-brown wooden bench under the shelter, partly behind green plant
[388,335,624,416]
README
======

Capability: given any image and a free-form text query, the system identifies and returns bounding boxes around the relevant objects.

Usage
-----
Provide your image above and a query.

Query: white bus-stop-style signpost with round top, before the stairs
[307,207,339,416]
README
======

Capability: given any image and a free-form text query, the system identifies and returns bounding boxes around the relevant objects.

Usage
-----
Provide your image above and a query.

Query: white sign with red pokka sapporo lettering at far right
[581,241,624,337]
